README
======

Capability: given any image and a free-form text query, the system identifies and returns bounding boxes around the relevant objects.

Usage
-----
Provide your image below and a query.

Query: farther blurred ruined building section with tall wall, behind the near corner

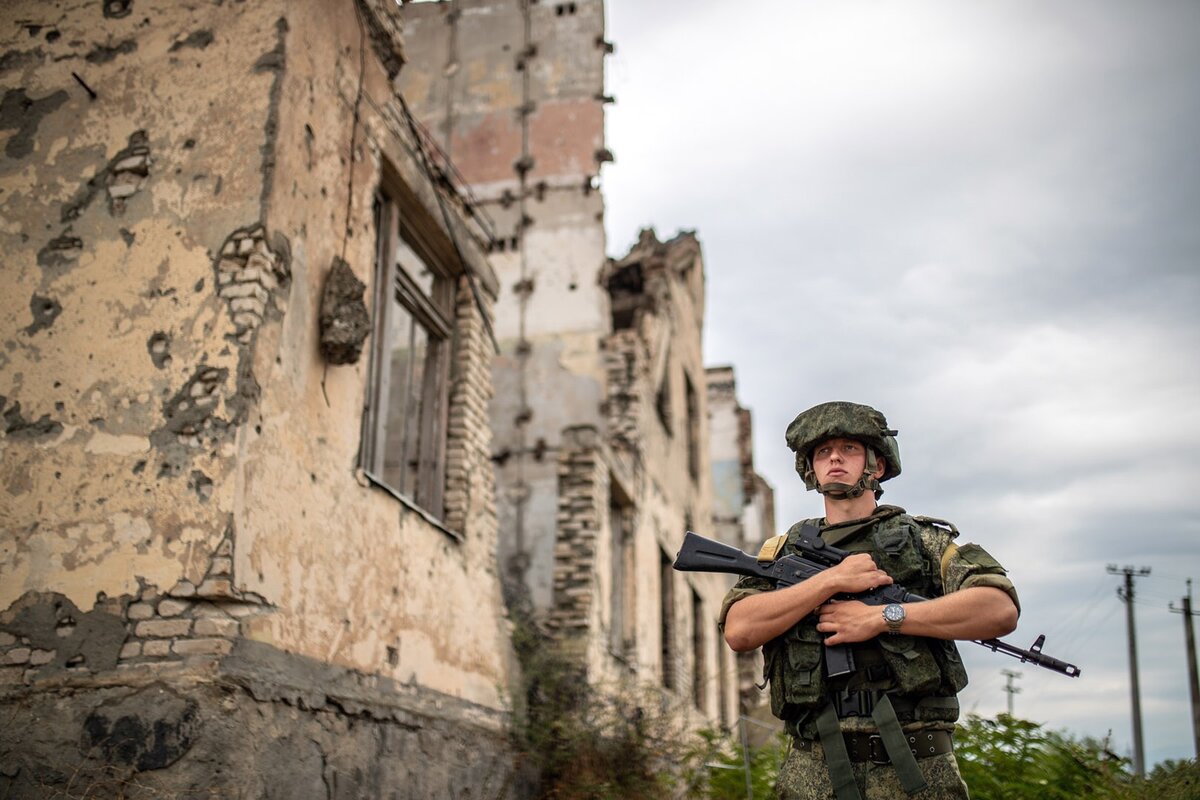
[400,0,773,727]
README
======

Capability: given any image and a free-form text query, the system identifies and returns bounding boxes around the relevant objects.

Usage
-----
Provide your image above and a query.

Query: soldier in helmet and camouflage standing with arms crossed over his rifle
[721,403,1019,800]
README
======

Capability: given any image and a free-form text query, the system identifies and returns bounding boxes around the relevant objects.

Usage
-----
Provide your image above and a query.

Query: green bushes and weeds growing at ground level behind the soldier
[512,604,1200,800]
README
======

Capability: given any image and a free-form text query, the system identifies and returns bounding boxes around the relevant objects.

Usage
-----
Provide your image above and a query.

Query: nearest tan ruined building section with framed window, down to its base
[0,0,512,798]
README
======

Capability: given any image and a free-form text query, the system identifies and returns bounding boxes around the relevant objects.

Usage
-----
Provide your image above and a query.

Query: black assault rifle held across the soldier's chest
[674,525,1079,678]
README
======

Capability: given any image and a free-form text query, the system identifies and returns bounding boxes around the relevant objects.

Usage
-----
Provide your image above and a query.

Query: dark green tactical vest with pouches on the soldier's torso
[763,506,967,735]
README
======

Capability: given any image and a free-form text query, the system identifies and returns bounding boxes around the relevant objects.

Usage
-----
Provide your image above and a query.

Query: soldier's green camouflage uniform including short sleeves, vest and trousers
[721,505,1019,800]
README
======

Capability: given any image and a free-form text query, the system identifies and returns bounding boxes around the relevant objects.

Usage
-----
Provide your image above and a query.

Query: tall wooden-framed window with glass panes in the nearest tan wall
[362,190,454,521]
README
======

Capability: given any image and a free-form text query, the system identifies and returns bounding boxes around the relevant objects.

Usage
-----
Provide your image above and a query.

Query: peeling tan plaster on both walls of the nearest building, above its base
[0,0,509,708]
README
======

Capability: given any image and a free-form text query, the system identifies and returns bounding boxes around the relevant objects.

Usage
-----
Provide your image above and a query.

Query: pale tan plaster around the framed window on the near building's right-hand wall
[235,0,508,705]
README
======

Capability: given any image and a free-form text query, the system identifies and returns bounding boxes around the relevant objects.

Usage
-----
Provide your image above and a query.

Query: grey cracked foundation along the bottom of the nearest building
[0,639,523,800]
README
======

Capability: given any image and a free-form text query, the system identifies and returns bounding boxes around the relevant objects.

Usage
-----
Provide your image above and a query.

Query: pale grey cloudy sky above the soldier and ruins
[604,0,1200,764]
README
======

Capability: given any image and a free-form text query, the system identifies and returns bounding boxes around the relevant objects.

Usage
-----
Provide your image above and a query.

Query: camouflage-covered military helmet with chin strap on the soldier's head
[787,402,900,497]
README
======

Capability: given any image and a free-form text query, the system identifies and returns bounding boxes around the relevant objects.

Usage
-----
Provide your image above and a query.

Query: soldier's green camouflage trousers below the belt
[775,742,970,800]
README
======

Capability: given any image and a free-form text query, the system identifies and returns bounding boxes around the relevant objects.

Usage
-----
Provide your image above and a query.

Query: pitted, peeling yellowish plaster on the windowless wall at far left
[0,2,277,608]
